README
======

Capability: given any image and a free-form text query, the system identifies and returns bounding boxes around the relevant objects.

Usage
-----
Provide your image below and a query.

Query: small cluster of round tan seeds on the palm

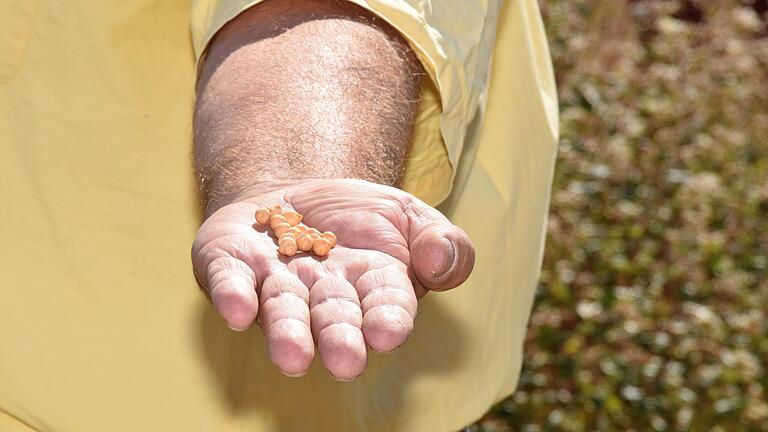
[256,205,336,256]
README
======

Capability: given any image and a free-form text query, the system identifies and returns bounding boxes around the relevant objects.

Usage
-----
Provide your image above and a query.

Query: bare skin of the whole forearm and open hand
[192,0,474,380]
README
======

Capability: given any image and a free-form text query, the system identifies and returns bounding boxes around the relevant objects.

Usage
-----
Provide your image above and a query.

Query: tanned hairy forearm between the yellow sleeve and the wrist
[194,0,423,210]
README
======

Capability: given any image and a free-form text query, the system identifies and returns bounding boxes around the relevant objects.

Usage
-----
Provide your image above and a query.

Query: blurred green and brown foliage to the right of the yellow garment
[471,0,768,432]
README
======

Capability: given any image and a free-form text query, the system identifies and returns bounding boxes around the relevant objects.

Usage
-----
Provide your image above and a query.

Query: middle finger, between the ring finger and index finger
[309,276,368,381]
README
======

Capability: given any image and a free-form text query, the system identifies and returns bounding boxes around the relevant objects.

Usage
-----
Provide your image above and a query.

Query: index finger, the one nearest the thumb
[355,266,417,352]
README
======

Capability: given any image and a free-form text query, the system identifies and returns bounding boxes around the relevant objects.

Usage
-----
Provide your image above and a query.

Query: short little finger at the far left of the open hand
[204,255,259,331]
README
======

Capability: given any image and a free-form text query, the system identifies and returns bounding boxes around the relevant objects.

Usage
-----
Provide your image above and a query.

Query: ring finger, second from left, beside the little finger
[260,272,315,376]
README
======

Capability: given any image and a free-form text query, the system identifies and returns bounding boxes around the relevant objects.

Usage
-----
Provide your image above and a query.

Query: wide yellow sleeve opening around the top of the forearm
[191,0,499,205]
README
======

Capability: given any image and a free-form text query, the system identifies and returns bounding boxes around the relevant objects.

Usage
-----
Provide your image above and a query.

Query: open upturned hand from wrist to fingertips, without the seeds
[192,179,475,380]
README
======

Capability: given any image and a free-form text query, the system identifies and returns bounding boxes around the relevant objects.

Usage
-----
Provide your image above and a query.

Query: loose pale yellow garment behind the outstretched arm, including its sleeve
[0,0,557,432]
